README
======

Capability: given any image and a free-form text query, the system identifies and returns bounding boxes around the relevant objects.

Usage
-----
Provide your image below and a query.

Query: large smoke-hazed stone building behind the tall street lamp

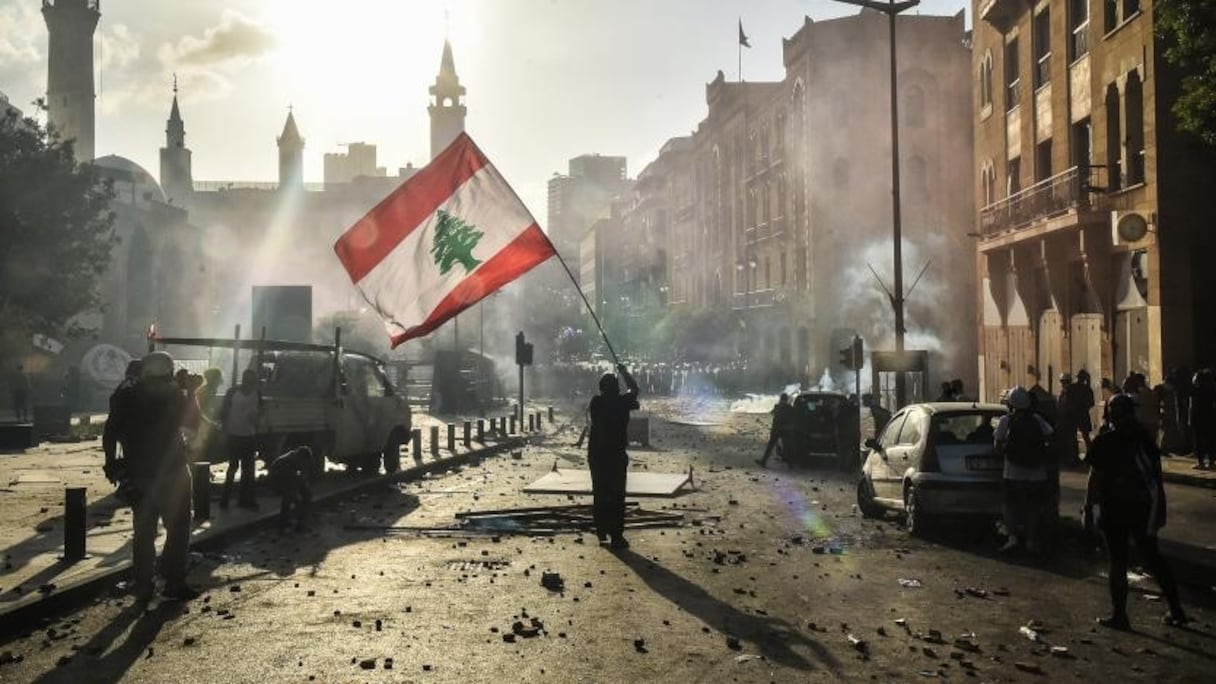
[612,10,976,389]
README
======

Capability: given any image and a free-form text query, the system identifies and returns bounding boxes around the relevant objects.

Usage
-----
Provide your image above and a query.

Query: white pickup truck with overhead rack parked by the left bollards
[156,337,411,472]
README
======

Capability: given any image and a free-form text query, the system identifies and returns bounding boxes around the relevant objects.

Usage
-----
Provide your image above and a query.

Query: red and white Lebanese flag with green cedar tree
[333,133,556,347]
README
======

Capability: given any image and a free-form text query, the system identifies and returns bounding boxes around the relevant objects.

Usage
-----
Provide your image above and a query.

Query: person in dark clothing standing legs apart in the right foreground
[1082,394,1187,629]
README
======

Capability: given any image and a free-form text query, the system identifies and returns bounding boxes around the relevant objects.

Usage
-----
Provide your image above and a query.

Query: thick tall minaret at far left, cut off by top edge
[43,0,101,162]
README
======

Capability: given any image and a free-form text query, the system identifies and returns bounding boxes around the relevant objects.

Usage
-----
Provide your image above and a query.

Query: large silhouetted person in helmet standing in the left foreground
[102,352,197,601]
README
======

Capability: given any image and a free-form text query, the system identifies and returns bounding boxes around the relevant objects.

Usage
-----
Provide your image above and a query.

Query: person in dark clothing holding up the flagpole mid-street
[587,364,640,549]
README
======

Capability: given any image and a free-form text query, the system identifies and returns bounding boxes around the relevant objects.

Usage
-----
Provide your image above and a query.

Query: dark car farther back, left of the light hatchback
[782,392,861,470]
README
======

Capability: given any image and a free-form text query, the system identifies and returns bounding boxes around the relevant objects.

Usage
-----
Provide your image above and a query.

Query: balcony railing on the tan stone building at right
[980,167,1105,237]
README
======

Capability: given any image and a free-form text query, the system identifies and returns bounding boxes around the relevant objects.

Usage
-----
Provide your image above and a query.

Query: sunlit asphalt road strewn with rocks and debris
[0,400,1216,683]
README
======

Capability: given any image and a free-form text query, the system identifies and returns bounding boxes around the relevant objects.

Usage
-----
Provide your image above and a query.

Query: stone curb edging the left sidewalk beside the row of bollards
[0,434,530,638]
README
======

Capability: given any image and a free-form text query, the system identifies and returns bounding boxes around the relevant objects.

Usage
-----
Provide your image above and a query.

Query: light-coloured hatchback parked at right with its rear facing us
[857,403,1006,534]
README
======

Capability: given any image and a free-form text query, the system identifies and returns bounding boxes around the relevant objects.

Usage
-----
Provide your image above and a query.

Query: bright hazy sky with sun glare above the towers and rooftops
[0,0,969,216]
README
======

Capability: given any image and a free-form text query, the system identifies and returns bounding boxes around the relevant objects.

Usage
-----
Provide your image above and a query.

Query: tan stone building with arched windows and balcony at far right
[972,0,1216,398]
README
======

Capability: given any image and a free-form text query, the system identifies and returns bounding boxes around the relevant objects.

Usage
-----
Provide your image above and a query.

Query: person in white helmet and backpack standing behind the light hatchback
[993,386,1052,553]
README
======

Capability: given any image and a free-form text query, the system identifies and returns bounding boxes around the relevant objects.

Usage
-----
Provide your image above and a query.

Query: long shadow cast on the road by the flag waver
[614,549,840,677]
